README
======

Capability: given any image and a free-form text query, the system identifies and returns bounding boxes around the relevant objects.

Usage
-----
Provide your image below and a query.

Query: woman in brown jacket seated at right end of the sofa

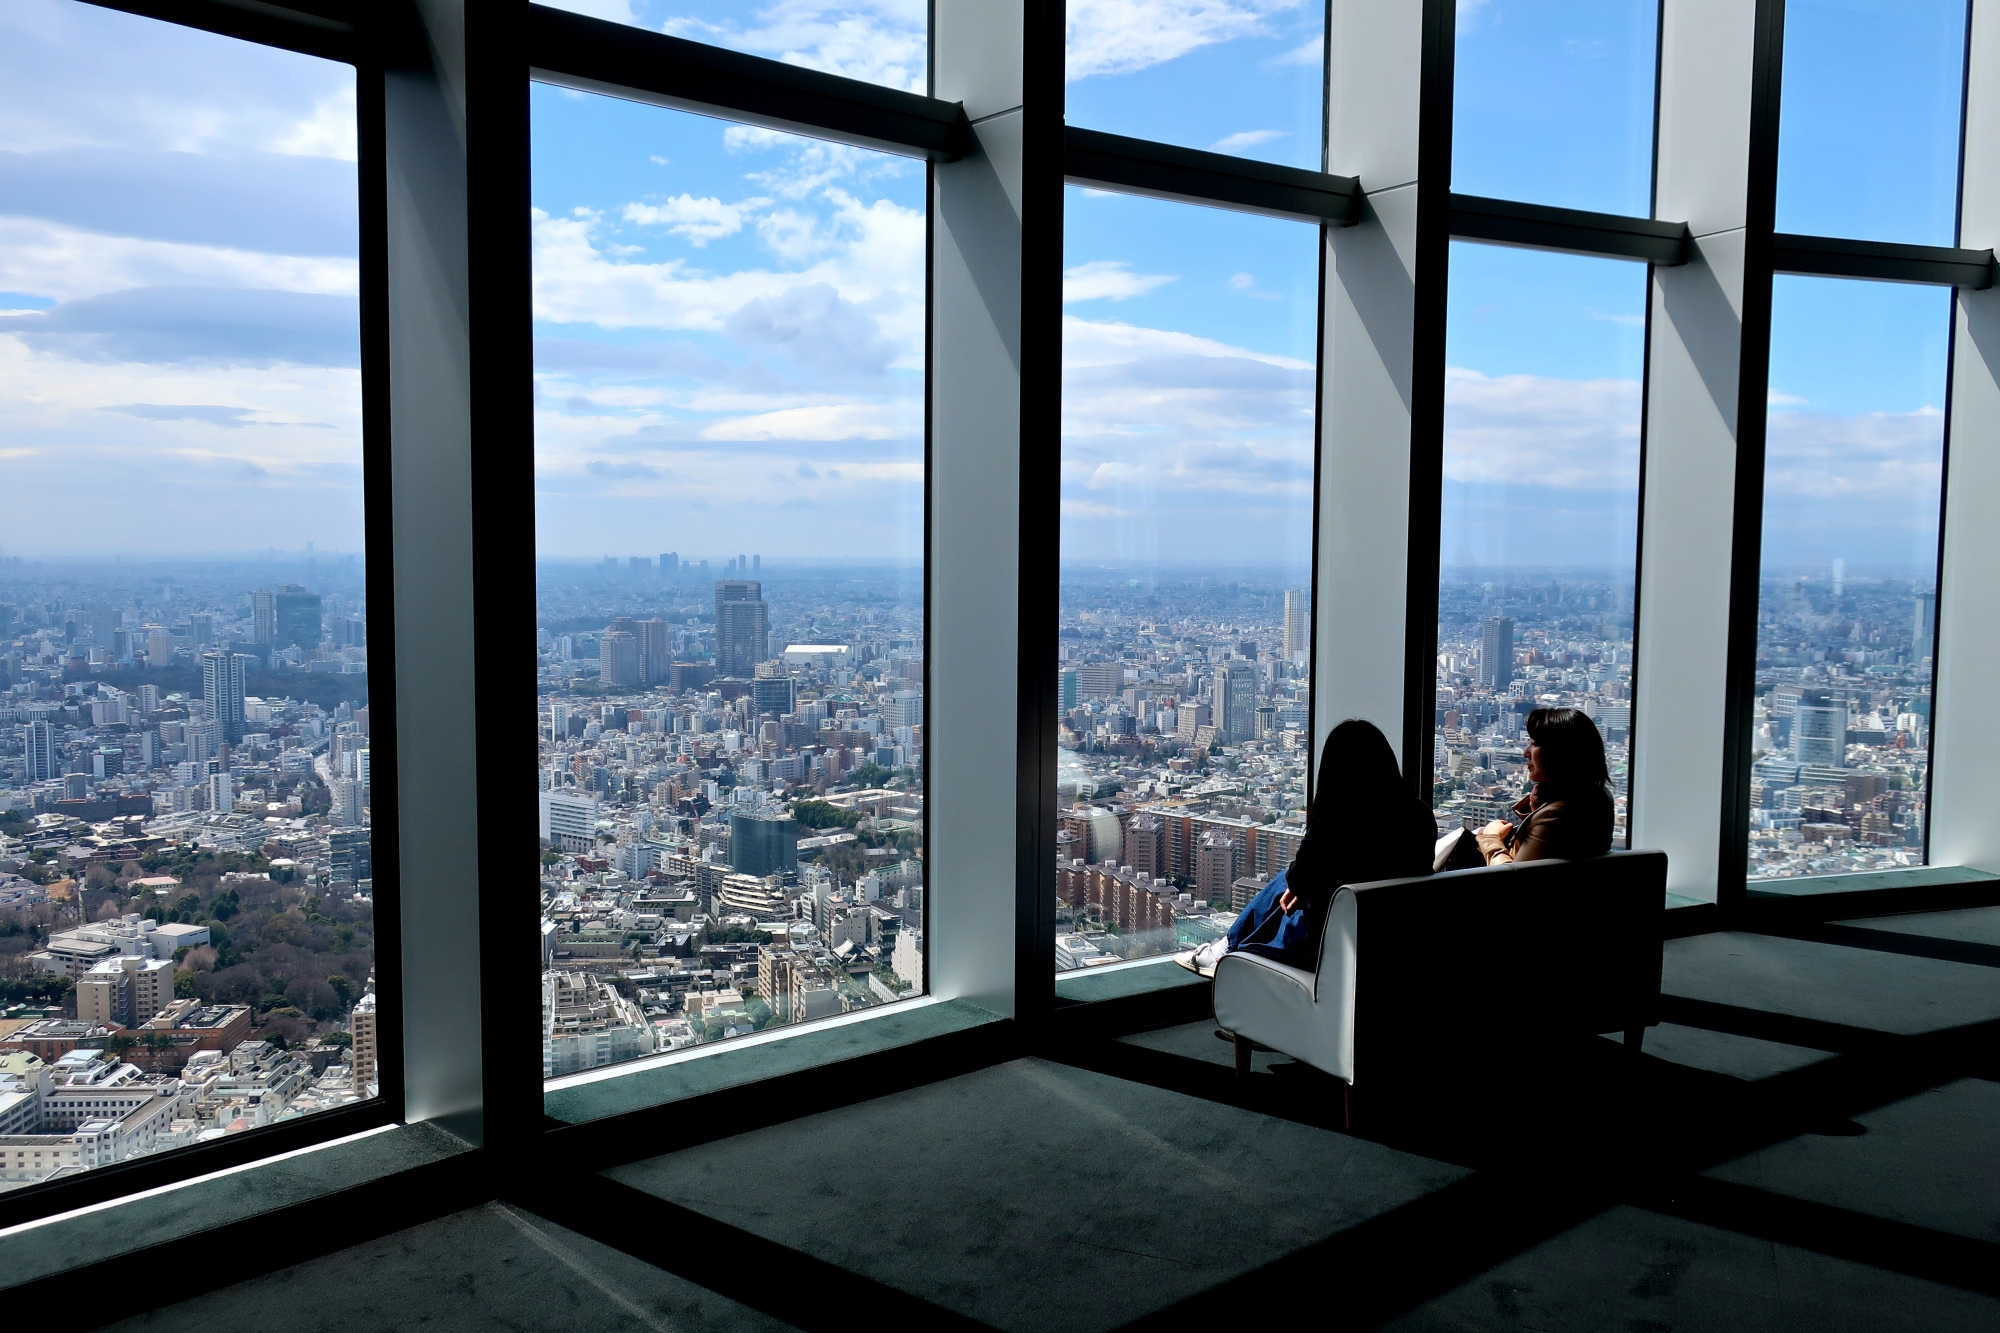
[1476,709,1612,865]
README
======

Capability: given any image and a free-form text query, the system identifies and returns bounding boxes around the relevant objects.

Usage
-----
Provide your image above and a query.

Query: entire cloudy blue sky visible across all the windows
[0,0,1964,564]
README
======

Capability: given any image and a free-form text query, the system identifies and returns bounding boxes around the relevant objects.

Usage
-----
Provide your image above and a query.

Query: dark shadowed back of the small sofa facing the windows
[1348,851,1666,1065]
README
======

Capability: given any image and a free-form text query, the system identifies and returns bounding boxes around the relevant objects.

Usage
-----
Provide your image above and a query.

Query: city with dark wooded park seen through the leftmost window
[0,544,380,1191]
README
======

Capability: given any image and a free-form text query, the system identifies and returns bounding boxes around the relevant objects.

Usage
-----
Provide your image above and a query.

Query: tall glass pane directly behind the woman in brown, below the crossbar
[1432,242,1646,847]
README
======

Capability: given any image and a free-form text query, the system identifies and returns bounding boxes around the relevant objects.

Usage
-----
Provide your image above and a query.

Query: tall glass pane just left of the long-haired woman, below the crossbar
[1056,186,1318,969]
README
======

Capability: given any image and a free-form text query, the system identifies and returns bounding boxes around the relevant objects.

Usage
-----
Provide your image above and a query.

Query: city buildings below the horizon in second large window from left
[536,552,924,1079]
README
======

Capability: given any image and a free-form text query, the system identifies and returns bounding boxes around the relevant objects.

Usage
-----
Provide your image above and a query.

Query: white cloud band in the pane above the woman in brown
[1444,366,1640,490]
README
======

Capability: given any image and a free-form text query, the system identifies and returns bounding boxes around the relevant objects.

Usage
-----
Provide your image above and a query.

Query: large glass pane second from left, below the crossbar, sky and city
[522,86,924,1077]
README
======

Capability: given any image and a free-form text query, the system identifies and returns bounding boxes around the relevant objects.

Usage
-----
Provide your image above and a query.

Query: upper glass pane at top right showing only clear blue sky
[1778,0,1966,246]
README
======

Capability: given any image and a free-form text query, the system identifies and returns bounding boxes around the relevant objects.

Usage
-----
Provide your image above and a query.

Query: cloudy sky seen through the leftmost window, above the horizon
[0,0,362,556]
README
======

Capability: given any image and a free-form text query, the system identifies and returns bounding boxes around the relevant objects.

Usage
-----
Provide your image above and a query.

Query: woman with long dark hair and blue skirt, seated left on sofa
[1176,719,1438,977]
